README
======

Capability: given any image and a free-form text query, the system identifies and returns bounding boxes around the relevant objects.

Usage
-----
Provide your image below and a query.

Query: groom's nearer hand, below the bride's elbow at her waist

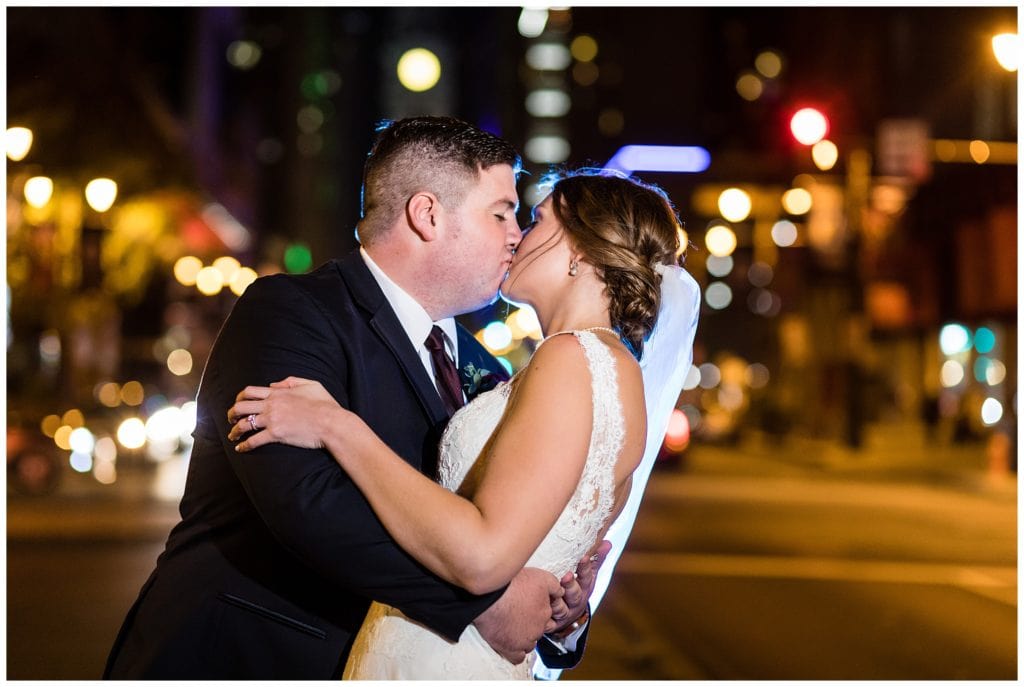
[473,568,564,664]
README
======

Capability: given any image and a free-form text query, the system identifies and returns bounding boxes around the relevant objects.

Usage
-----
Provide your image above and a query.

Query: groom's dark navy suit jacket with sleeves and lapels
[103,251,578,680]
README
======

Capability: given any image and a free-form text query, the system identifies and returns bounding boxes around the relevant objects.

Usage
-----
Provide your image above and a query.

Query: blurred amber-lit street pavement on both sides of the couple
[7,428,1017,680]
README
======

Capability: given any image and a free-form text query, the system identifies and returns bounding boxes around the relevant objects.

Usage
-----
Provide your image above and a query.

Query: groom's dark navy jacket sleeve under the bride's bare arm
[198,277,504,640]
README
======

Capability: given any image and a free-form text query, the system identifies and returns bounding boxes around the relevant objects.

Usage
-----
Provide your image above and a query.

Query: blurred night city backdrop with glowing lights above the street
[5,6,1019,499]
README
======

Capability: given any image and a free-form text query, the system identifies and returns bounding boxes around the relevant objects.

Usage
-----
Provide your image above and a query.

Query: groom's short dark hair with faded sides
[358,117,522,246]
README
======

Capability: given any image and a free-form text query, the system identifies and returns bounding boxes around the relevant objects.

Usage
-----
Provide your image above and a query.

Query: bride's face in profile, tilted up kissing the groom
[501,196,572,306]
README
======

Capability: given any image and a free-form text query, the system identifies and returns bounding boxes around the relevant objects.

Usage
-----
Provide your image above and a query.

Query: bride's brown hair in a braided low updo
[545,169,681,360]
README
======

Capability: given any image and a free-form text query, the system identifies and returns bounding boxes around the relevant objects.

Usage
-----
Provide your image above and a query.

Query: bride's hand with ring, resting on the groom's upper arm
[227,377,354,453]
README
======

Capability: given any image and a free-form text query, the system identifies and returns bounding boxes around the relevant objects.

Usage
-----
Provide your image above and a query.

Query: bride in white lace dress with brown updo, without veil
[229,171,692,680]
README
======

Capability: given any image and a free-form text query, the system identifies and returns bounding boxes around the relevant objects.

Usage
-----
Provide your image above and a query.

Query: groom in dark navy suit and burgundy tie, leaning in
[103,117,600,680]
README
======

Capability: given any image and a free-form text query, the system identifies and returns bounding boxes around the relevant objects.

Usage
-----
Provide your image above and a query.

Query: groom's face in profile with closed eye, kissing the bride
[438,165,522,312]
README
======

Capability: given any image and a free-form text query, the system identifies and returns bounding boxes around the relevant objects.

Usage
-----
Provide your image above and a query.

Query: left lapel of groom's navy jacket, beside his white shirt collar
[341,251,449,425]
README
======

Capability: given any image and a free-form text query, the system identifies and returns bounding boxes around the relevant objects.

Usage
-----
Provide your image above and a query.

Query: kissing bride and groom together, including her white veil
[103,117,699,680]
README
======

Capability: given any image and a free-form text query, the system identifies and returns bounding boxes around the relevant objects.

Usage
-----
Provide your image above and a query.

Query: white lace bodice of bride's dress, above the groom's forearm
[438,330,626,577]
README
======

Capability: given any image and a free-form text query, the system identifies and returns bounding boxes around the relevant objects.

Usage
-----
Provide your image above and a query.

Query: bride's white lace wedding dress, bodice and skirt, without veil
[344,330,625,680]
